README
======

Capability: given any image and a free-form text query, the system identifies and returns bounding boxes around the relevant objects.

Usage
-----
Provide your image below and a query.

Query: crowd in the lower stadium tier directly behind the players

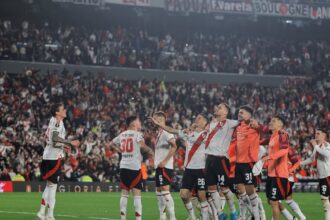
[0,70,330,182]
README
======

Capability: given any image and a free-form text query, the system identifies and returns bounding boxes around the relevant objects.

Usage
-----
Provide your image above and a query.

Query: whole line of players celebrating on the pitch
[38,103,330,220]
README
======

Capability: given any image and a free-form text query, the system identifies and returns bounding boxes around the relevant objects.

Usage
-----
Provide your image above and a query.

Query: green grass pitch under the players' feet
[0,192,324,220]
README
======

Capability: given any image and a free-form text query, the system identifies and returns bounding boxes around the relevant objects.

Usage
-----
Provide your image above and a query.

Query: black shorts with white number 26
[181,169,206,191]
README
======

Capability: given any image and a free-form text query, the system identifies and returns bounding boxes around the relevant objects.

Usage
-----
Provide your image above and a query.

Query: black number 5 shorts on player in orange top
[266,177,290,201]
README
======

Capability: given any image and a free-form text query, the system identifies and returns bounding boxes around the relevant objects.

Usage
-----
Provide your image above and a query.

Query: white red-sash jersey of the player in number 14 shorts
[205,119,239,158]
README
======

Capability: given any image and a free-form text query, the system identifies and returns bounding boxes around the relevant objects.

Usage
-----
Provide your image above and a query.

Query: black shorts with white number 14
[206,155,230,186]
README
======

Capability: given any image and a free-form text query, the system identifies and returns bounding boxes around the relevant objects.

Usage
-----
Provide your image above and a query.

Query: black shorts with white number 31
[235,163,257,186]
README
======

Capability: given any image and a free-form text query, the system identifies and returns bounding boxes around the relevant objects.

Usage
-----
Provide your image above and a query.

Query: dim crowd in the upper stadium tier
[0,20,330,75]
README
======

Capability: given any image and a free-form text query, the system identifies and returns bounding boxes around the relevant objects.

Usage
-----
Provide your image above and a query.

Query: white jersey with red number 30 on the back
[113,130,143,170]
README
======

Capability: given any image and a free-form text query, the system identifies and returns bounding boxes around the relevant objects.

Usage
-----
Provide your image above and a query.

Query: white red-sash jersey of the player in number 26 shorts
[179,130,207,169]
